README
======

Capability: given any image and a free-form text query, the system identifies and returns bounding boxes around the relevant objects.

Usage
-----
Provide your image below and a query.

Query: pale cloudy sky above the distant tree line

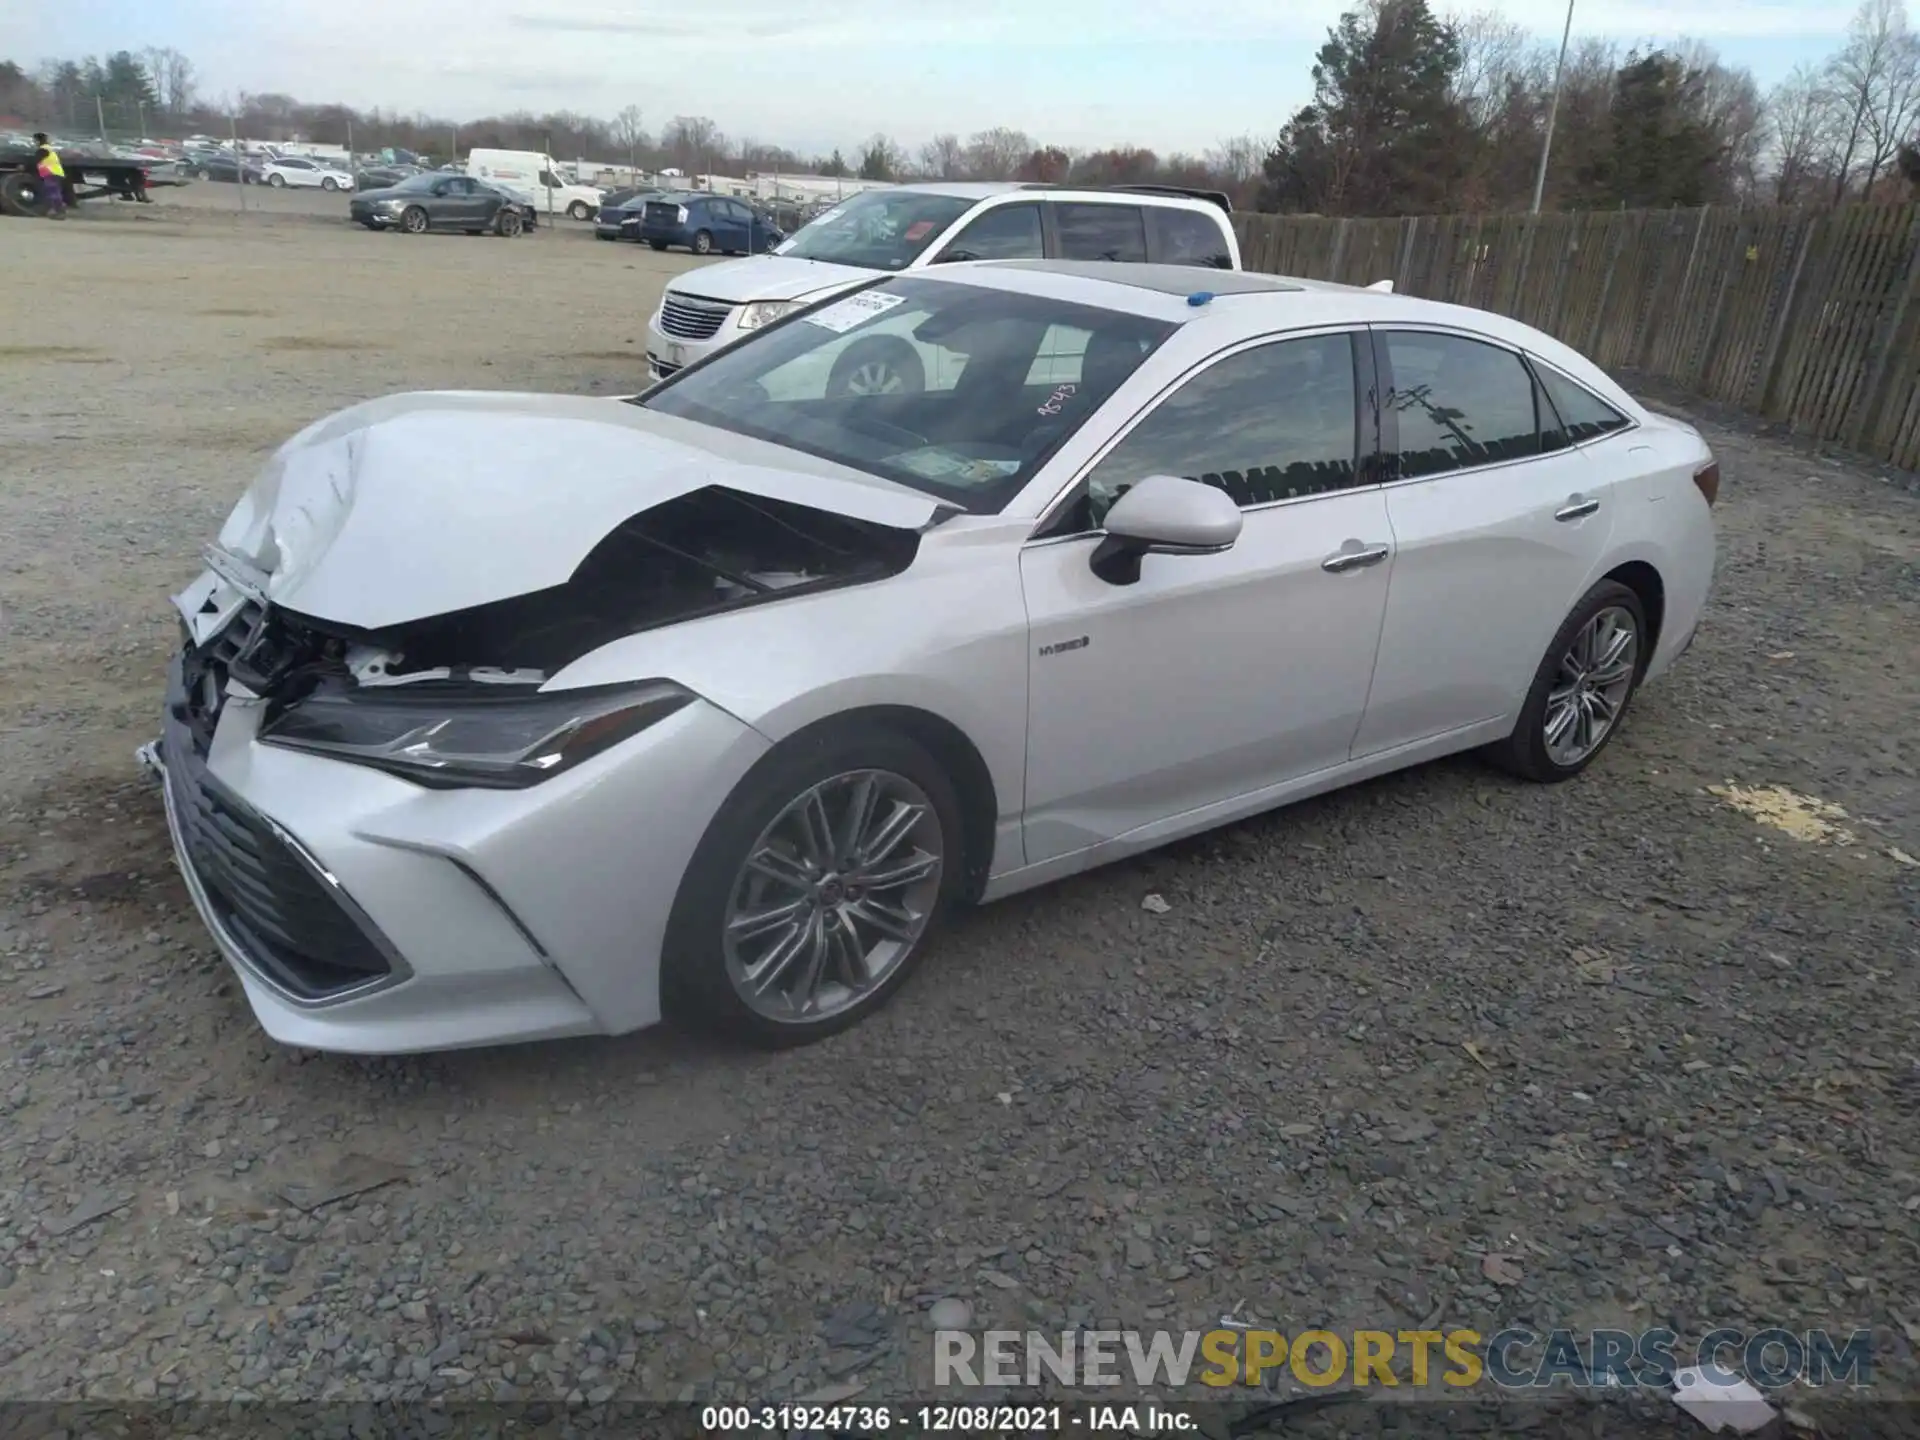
[11,0,1851,152]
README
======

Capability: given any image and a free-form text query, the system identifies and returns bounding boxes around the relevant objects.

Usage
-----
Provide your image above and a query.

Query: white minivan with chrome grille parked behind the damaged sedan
[647,182,1240,392]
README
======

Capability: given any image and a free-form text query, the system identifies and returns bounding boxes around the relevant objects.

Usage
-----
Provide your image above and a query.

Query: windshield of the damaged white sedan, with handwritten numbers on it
[632,276,1173,515]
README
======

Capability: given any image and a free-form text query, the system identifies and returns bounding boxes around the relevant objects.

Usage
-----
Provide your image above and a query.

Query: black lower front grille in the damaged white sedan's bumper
[161,702,394,1000]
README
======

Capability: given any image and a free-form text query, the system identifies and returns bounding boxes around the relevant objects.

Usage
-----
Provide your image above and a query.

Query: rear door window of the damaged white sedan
[1380,330,1540,480]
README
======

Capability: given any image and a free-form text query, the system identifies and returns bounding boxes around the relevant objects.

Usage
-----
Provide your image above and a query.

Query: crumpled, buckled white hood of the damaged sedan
[219,392,948,630]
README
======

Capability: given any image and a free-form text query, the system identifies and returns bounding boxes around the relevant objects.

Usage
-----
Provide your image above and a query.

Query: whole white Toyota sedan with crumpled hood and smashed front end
[142,261,1718,1052]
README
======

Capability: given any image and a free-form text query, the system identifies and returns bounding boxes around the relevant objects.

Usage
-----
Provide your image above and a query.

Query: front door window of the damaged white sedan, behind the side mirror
[1062,334,1361,534]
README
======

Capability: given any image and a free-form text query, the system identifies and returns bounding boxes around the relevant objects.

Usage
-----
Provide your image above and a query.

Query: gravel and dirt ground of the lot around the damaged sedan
[0,186,1920,1409]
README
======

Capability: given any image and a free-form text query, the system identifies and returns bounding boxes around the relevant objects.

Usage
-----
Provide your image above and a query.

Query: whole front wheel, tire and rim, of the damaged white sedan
[660,724,966,1048]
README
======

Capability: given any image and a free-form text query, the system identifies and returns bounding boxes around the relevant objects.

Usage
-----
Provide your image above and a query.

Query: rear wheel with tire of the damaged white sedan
[1488,580,1651,785]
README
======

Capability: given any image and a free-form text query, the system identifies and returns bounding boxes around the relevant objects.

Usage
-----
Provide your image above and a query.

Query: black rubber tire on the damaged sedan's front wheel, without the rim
[660,724,966,1048]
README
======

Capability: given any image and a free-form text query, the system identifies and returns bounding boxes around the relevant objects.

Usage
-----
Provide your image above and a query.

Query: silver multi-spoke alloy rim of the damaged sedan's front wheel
[722,770,947,1023]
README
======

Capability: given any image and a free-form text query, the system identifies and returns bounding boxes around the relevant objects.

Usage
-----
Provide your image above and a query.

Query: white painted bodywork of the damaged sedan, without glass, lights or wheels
[157,265,1715,1052]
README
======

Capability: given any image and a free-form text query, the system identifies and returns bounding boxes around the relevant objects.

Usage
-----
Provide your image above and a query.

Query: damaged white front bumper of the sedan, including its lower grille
[140,602,766,1054]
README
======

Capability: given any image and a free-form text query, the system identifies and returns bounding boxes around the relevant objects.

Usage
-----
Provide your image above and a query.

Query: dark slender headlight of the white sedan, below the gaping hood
[259,680,693,789]
